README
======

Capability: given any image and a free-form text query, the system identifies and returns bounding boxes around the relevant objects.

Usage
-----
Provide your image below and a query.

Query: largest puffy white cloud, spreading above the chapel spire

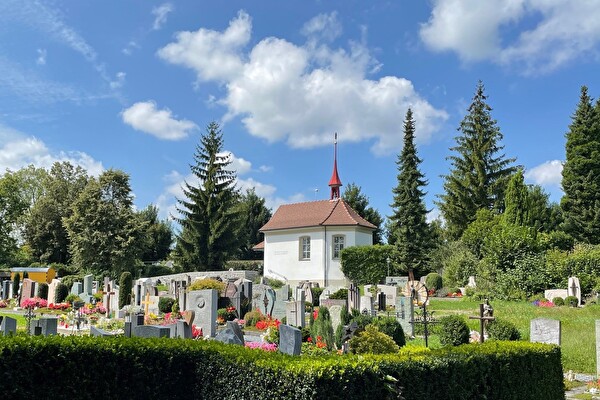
[158,11,448,154]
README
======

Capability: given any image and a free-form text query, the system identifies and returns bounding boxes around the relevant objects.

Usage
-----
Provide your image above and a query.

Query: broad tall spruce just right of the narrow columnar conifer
[436,81,516,239]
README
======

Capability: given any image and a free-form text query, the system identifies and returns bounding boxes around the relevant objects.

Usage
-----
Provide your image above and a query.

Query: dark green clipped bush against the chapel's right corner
[341,245,394,285]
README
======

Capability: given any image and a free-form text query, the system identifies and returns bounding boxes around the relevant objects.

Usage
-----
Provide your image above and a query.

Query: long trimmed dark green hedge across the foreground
[0,336,564,400]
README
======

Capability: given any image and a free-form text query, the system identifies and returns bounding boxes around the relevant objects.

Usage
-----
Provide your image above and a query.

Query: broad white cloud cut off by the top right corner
[420,0,600,74]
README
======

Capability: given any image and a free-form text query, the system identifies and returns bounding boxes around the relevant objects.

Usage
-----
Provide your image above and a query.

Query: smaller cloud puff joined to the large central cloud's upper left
[157,11,252,81]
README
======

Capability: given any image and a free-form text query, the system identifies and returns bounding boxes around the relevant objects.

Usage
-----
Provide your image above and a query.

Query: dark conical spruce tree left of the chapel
[174,122,241,271]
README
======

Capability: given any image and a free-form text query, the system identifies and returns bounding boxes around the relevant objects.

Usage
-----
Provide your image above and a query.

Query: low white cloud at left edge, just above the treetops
[0,124,104,176]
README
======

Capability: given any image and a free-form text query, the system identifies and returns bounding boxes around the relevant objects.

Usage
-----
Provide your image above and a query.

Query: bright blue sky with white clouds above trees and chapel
[0,0,600,225]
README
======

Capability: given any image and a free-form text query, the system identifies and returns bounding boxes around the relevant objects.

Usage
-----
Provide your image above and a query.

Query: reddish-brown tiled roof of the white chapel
[260,199,377,232]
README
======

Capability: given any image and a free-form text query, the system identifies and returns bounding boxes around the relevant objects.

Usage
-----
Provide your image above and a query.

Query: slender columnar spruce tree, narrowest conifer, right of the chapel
[390,108,431,275]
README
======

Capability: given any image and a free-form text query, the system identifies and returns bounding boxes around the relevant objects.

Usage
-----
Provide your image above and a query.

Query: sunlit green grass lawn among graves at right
[411,298,600,374]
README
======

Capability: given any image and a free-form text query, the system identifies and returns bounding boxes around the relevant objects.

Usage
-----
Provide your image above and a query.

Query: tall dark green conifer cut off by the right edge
[560,86,600,244]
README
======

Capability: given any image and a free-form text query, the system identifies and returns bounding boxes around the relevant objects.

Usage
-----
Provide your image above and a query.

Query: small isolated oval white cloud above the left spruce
[121,101,198,140]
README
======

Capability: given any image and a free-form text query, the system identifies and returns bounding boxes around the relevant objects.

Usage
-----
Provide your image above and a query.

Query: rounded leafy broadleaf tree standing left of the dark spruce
[63,169,146,278]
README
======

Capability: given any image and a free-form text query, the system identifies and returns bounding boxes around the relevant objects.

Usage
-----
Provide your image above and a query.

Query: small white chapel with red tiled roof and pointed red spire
[256,140,377,287]
